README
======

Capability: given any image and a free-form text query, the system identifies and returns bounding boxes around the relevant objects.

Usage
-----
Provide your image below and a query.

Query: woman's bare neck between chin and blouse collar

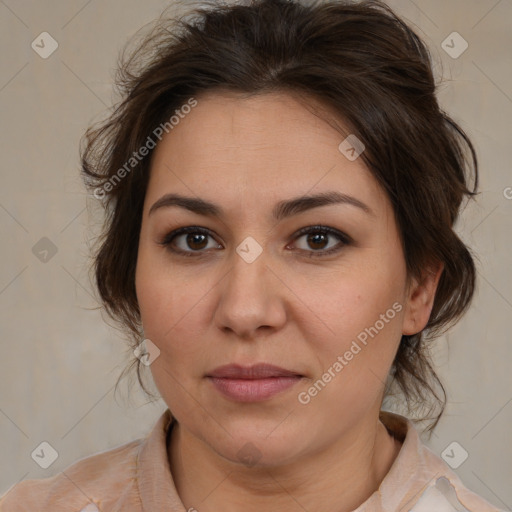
[168,412,401,512]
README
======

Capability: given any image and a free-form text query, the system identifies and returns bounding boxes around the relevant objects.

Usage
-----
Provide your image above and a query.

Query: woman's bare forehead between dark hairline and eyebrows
[147,92,385,217]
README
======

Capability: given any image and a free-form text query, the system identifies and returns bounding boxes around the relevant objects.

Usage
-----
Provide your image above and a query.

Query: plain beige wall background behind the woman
[0,0,512,510]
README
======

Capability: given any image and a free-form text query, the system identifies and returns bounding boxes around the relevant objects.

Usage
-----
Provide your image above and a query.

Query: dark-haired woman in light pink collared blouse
[0,0,504,512]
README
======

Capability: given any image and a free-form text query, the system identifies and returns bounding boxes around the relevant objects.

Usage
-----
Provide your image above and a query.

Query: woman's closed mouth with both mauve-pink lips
[206,363,304,402]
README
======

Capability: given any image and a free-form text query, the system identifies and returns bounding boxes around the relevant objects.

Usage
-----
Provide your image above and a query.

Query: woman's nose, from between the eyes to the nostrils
[215,247,287,340]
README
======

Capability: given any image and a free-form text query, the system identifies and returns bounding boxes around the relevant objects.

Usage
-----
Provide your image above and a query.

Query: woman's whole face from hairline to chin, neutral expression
[136,93,431,464]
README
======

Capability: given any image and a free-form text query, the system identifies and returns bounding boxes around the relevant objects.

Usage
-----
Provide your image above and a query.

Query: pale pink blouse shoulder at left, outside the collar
[0,439,144,512]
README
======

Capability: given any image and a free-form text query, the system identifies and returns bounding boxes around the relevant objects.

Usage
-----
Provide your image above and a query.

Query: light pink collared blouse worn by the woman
[0,409,500,512]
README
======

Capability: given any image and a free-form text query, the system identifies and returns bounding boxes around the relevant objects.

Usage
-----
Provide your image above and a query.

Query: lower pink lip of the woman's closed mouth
[210,376,301,402]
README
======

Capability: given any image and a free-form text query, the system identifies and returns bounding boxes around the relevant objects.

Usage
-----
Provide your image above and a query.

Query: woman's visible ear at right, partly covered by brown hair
[402,262,444,336]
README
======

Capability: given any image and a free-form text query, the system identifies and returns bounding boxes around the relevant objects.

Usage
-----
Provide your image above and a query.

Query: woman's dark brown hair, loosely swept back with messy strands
[81,0,478,430]
